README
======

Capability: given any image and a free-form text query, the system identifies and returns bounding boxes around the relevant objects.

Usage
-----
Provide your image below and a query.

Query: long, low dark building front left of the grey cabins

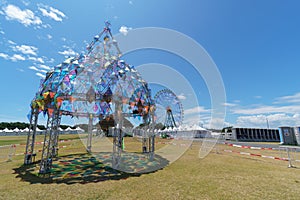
[232,128,280,142]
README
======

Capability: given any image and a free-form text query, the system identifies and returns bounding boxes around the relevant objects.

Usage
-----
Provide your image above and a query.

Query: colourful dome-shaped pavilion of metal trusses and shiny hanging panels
[24,23,154,174]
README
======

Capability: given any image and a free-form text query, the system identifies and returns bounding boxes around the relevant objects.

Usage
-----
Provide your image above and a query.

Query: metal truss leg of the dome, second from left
[39,108,61,174]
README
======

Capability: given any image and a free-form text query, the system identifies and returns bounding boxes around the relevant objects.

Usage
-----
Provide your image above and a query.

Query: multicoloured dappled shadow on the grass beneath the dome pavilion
[14,152,169,184]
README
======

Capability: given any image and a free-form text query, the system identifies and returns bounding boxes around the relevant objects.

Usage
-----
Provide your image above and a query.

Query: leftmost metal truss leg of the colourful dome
[24,108,39,165]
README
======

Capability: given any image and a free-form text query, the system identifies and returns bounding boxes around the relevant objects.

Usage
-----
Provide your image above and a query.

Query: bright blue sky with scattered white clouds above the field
[0,0,300,128]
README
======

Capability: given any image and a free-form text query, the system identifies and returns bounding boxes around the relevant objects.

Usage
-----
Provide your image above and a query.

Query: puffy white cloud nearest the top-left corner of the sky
[3,4,42,27]
